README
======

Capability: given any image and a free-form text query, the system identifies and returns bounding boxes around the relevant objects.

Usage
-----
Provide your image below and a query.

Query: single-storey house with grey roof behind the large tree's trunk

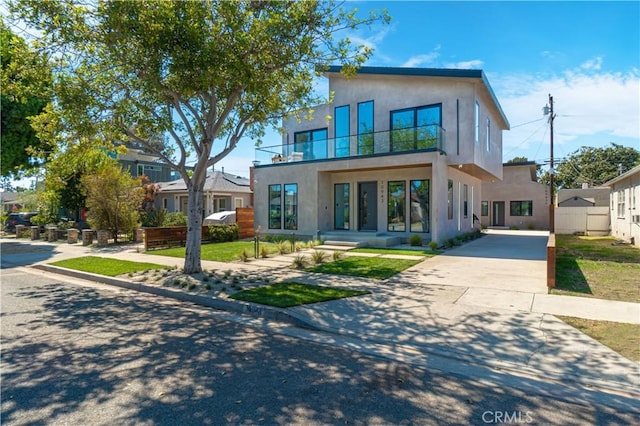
[155,169,252,216]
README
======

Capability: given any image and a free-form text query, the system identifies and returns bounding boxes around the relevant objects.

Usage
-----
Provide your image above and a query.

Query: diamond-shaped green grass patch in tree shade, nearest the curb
[229,282,368,308]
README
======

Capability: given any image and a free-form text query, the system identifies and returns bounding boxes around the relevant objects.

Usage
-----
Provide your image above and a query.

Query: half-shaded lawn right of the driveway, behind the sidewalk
[552,235,640,303]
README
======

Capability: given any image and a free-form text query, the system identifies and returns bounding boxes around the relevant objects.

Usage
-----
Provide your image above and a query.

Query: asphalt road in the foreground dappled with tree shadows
[0,265,640,426]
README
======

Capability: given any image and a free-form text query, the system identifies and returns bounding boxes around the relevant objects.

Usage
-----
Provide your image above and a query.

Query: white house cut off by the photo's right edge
[604,166,640,247]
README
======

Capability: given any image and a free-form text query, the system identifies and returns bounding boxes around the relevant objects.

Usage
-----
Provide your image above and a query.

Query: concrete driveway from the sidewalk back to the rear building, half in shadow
[393,230,549,294]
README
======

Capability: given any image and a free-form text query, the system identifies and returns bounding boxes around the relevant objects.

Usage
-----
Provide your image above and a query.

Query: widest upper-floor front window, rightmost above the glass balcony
[390,104,442,151]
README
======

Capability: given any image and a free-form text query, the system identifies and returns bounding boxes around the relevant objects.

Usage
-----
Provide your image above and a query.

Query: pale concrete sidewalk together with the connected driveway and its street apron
[2,231,640,408]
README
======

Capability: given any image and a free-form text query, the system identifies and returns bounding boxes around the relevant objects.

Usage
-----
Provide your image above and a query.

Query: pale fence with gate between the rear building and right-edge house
[555,207,611,235]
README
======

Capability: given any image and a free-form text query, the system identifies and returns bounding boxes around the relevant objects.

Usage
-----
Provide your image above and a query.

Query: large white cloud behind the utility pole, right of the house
[489,67,640,159]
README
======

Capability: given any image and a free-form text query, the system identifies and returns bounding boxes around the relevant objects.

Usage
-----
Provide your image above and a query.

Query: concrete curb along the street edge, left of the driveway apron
[31,264,319,331]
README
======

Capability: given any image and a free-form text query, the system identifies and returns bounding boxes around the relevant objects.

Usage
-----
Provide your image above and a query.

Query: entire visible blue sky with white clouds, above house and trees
[216,1,640,176]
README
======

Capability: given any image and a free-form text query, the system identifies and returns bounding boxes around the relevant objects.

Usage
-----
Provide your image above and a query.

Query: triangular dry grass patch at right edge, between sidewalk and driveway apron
[556,315,640,362]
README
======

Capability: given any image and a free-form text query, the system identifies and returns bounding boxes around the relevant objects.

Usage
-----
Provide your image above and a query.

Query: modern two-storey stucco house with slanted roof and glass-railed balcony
[252,67,509,246]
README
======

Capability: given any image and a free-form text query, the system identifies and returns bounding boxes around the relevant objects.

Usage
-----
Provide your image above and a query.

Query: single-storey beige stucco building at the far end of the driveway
[480,161,549,229]
